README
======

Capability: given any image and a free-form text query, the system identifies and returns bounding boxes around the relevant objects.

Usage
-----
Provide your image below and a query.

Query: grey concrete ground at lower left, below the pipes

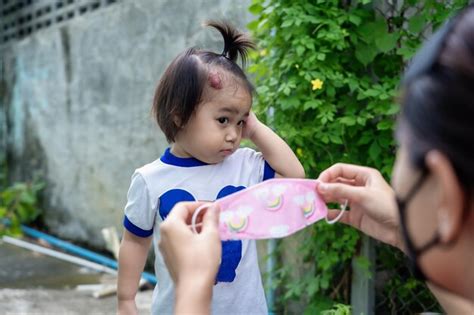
[0,239,152,315]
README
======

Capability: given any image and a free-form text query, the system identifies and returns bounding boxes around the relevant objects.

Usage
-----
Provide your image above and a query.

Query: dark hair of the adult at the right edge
[400,5,474,190]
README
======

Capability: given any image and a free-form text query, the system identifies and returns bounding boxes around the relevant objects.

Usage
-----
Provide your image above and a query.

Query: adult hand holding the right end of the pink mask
[317,163,403,250]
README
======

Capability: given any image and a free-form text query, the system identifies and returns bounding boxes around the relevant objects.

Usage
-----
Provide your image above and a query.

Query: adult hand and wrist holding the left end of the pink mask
[159,202,222,314]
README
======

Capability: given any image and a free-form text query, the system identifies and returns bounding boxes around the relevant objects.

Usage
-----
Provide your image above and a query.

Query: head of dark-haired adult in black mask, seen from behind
[393,5,474,299]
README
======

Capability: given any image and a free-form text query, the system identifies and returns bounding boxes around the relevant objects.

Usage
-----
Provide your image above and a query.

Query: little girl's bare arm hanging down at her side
[117,230,152,315]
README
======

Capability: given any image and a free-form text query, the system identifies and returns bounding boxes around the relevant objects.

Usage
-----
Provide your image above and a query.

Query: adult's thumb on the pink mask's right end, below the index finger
[317,182,366,204]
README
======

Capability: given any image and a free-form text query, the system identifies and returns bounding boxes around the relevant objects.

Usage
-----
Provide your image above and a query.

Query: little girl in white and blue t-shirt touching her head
[118,22,304,314]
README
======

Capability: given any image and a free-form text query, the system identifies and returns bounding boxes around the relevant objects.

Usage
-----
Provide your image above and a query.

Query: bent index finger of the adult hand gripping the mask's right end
[318,163,371,186]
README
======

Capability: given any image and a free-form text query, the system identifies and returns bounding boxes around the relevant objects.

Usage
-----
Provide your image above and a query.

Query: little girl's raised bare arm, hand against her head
[243,112,305,178]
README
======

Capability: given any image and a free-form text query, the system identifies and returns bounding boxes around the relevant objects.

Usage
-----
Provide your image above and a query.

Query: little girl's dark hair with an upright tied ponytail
[152,21,255,142]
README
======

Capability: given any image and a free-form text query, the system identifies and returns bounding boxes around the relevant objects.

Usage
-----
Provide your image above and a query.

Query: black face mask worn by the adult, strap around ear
[396,170,440,281]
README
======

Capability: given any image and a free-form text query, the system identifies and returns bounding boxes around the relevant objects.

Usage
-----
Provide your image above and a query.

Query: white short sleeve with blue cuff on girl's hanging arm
[123,172,156,237]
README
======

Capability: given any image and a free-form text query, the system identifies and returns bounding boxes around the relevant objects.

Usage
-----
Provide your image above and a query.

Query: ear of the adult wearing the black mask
[425,150,466,244]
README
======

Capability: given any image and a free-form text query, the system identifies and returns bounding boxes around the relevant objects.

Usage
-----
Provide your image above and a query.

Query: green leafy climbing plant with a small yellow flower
[248,0,468,310]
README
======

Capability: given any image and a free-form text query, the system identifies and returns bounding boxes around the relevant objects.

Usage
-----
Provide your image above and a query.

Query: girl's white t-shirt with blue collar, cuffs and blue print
[124,148,275,315]
